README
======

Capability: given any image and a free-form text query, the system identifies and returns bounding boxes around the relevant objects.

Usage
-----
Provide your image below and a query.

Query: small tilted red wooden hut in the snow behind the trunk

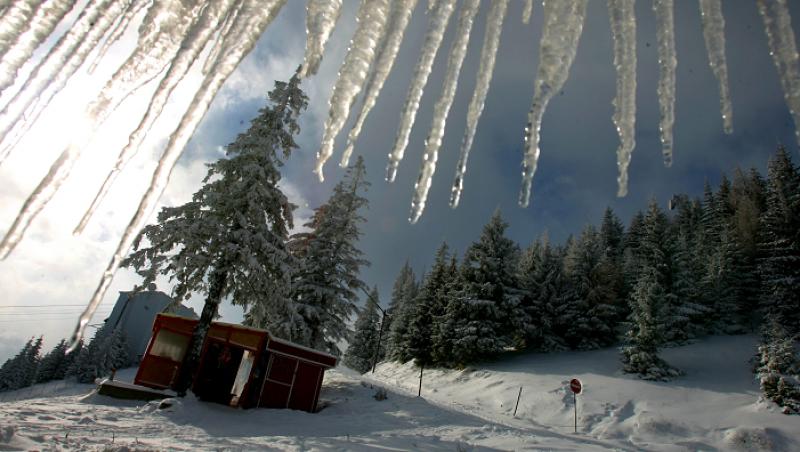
[134,314,336,412]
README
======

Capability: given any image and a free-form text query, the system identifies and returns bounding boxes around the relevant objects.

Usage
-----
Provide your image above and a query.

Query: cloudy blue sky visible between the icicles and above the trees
[0,0,800,360]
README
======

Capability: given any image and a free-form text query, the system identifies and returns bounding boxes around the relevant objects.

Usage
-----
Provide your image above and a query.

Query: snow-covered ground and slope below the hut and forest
[0,336,800,451]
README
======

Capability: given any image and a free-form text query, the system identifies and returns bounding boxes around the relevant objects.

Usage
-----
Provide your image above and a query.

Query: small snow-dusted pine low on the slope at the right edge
[756,319,800,414]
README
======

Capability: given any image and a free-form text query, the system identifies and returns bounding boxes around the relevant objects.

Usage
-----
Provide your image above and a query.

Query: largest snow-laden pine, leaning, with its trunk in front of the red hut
[122,75,307,394]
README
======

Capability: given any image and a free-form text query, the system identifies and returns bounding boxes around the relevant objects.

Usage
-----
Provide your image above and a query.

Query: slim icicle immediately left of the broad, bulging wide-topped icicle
[450,0,508,208]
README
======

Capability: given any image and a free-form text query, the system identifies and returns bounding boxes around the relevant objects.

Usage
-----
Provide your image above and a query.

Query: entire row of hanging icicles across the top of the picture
[0,0,800,350]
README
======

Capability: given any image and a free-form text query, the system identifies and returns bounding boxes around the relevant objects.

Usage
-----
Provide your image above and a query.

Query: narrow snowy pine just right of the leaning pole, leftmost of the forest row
[386,261,417,362]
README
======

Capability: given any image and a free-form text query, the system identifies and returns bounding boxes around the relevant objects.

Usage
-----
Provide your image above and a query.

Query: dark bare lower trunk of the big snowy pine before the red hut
[174,268,227,397]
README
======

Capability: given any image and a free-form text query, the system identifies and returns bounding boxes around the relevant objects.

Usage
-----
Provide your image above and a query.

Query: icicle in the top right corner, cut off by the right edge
[757,0,800,149]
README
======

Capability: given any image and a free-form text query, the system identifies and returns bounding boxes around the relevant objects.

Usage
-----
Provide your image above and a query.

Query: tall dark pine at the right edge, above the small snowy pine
[759,147,800,335]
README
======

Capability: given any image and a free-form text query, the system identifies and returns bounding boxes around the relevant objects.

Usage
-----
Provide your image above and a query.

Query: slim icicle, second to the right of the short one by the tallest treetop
[339,0,417,168]
